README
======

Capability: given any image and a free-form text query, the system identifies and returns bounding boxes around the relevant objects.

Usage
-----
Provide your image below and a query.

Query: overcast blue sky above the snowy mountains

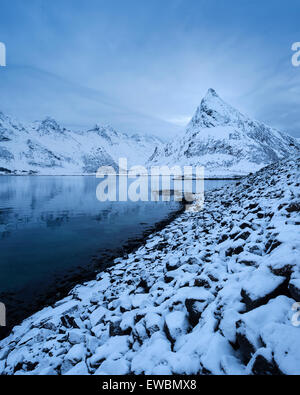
[0,0,300,139]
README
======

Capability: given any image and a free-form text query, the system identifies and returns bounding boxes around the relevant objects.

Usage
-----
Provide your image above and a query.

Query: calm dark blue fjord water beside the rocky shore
[0,176,234,332]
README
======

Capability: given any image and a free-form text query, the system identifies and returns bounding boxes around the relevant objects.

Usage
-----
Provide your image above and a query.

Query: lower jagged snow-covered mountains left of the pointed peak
[0,112,161,175]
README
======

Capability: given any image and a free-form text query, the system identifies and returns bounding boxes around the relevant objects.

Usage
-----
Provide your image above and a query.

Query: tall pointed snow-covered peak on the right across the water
[148,89,300,178]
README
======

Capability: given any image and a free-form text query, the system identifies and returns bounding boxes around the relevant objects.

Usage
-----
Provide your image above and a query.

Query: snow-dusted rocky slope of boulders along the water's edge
[0,158,300,375]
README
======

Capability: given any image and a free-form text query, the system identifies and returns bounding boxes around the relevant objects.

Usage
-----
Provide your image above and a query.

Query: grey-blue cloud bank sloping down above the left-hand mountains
[0,67,179,138]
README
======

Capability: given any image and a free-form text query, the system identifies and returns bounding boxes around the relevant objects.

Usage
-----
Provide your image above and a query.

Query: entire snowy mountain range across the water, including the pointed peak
[0,89,300,178]
